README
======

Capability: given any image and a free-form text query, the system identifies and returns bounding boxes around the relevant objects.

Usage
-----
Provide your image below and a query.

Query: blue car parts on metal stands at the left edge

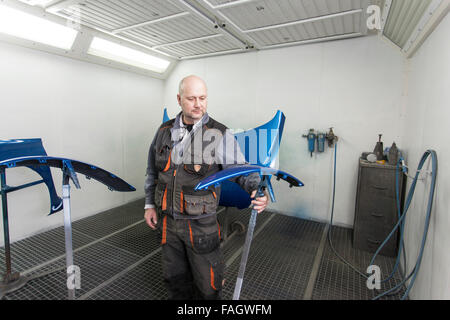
[0,139,136,299]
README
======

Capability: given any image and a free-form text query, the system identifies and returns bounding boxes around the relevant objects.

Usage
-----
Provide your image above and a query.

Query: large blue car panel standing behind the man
[163,108,286,209]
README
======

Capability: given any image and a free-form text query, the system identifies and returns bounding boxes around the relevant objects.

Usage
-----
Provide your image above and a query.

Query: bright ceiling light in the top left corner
[0,5,77,50]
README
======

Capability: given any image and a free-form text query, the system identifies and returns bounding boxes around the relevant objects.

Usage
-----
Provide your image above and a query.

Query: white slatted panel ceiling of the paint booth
[17,0,438,58]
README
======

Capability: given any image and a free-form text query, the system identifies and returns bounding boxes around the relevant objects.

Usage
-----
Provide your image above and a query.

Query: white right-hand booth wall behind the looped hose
[402,15,450,300]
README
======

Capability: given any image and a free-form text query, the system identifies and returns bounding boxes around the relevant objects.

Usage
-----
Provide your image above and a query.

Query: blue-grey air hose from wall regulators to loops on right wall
[327,142,437,300]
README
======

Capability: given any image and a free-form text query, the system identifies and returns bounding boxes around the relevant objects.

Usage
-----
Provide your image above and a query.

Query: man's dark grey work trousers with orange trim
[158,210,225,300]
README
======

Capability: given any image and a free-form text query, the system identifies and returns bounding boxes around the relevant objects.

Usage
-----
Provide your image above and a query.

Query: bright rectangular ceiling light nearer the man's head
[88,37,170,73]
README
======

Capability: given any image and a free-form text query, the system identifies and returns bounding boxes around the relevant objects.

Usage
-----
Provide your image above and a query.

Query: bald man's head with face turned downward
[177,78,208,124]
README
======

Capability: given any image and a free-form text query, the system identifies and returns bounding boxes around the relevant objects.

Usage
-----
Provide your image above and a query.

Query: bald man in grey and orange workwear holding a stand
[145,75,268,300]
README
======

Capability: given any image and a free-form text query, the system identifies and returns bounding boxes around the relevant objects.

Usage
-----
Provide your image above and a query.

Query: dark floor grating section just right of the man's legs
[224,215,323,300]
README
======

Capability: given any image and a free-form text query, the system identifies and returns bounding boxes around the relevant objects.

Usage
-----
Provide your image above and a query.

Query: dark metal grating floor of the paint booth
[0,199,408,300]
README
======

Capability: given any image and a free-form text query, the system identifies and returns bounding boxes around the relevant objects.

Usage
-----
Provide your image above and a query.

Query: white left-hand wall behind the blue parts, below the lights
[0,43,164,245]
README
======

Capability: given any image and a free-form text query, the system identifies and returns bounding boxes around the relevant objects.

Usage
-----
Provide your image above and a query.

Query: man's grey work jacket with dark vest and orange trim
[145,113,260,218]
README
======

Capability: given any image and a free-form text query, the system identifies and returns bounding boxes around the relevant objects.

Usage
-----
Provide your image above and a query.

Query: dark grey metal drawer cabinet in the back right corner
[353,159,405,257]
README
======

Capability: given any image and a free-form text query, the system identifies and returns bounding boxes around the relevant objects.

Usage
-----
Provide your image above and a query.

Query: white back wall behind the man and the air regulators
[164,36,403,226]
